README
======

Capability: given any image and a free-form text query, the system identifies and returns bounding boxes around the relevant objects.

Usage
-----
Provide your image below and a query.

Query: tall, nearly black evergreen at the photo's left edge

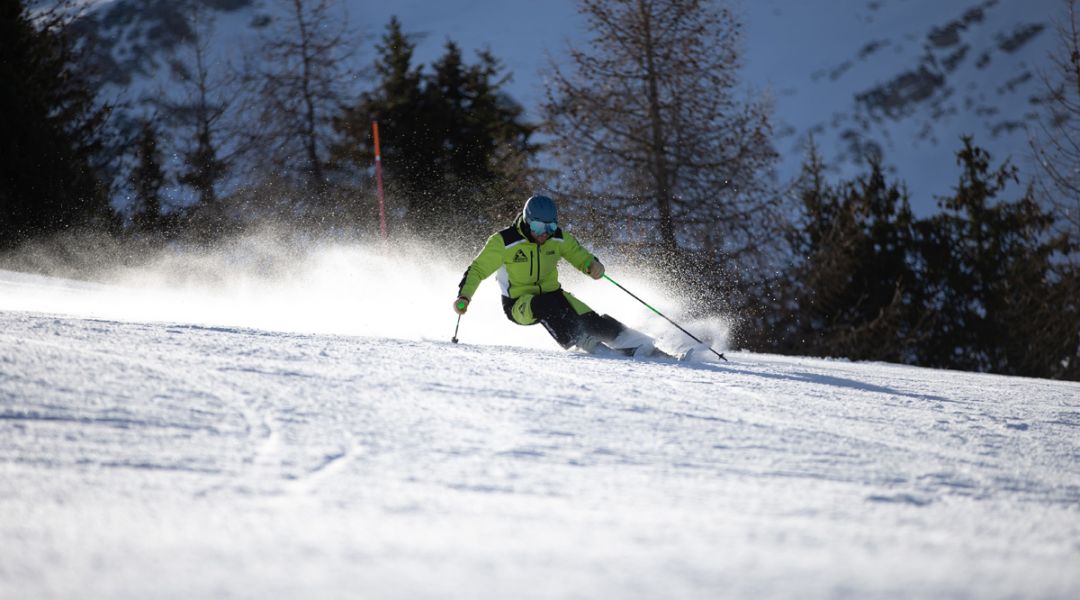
[0,0,116,247]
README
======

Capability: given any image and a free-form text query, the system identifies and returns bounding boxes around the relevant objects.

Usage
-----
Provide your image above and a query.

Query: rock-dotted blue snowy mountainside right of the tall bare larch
[746,0,1066,213]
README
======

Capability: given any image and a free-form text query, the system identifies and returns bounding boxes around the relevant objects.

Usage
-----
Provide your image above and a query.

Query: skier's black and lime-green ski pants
[502,289,626,349]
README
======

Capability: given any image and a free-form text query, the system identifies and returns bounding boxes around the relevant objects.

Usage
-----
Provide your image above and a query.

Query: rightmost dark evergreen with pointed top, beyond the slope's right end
[918,138,1080,378]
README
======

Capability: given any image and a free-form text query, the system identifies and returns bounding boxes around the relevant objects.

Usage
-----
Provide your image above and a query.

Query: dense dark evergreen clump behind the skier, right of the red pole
[335,18,536,241]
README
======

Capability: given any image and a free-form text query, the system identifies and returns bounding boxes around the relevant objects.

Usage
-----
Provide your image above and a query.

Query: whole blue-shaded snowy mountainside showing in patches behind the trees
[69,0,1065,213]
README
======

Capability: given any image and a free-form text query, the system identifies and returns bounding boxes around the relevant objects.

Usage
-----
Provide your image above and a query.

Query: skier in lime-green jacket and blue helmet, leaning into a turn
[454,195,670,357]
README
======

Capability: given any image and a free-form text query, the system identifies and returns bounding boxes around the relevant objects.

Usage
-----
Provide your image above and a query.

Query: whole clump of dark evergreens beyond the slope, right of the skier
[739,138,1080,379]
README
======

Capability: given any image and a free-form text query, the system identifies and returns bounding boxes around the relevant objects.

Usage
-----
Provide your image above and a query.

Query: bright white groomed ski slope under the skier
[0,242,1080,599]
